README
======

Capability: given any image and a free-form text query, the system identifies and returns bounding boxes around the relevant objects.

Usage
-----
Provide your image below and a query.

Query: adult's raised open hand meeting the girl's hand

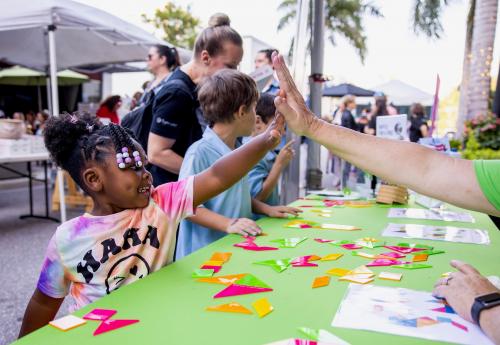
[272,53,322,136]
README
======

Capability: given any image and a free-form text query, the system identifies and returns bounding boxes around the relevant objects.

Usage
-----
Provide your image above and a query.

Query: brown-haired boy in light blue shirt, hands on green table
[176,69,300,259]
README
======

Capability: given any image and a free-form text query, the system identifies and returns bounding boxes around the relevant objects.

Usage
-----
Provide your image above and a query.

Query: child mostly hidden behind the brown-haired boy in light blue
[248,93,295,206]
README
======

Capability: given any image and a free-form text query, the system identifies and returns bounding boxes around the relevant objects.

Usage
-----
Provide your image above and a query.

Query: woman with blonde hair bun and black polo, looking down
[148,14,243,186]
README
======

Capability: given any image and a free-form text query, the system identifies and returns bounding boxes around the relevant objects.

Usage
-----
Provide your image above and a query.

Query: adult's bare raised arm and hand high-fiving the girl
[273,56,500,216]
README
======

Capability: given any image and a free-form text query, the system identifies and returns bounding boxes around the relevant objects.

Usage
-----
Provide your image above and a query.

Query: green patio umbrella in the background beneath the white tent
[0,66,89,86]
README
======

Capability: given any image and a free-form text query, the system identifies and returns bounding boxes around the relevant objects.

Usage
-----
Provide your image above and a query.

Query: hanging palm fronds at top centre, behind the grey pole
[278,0,383,61]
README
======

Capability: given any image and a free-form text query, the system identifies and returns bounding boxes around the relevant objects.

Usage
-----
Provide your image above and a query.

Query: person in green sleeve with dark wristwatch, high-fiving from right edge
[273,51,500,344]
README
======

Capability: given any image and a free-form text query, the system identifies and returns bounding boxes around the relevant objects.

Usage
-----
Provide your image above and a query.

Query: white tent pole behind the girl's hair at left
[48,25,66,223]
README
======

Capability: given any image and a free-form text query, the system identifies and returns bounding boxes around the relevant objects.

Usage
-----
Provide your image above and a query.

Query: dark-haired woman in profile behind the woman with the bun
[138,44,181,105]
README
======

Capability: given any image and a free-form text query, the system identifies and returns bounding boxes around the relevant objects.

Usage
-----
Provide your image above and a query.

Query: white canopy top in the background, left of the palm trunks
[370,80,434,106]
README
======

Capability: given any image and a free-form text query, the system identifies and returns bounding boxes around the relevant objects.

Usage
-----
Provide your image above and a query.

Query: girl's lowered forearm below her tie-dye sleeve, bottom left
[19,289,64,338]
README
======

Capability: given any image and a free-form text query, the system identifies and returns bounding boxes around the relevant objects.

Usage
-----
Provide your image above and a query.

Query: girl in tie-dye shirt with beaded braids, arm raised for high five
[20,111,283,336]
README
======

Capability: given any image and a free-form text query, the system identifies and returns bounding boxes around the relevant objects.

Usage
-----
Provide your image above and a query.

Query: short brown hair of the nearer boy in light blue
[198,69,259,126]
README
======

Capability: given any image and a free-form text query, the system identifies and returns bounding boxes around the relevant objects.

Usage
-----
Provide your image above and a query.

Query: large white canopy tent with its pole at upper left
[0,0,168,222]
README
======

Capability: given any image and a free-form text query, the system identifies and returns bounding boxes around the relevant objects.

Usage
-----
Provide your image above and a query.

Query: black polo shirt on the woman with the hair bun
[150,68,202,186]
